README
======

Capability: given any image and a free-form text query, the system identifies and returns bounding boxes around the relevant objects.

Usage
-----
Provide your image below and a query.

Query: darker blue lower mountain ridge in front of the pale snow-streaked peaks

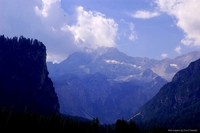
[53,73,165,123]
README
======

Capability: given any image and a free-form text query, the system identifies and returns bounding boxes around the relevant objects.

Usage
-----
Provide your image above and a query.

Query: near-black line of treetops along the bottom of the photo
[0,107,173,133]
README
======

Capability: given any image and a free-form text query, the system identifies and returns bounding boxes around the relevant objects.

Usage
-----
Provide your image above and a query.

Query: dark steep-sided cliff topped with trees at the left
[0,36,59,114]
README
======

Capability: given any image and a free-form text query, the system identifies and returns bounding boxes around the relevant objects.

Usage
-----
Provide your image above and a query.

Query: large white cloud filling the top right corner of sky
[155,0,200,46]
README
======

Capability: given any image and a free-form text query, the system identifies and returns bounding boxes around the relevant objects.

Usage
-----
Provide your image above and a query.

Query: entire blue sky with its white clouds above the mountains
[0,0,200,62]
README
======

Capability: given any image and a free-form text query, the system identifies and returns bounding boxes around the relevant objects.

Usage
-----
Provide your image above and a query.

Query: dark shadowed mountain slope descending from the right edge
[132,59,200,129]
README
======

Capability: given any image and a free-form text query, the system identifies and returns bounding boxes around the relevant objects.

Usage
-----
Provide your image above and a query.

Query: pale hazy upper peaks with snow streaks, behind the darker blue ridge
[47,47,200,81]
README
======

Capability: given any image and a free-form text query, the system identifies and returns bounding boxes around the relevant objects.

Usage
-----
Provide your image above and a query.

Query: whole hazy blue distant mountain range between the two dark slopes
[47,47,200,123]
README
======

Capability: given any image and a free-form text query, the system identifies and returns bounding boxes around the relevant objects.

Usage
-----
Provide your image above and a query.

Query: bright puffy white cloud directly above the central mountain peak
[62,6,118,48]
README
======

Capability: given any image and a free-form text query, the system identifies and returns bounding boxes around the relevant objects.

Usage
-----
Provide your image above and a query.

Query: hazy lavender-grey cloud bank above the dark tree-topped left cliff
[0,0,74,62]
